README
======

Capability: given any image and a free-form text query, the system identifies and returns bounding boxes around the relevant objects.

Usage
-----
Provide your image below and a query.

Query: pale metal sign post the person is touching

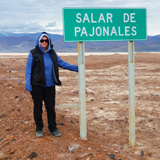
[78,42,87,139]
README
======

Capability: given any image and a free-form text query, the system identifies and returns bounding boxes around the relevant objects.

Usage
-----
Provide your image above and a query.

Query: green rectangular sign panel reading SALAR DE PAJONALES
[63,8,147,42]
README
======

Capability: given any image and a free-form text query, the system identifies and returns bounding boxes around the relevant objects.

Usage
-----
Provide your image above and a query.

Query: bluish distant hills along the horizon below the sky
[0,32,160,52]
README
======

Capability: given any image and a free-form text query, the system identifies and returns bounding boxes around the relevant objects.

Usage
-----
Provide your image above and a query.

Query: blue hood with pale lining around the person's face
[36,32,53,52]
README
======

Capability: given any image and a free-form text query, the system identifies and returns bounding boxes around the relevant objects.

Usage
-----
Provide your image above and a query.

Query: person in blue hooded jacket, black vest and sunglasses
[25,32,78,137]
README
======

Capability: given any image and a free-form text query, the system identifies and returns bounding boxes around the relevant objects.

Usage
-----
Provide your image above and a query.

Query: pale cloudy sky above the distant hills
[0,0,160,35]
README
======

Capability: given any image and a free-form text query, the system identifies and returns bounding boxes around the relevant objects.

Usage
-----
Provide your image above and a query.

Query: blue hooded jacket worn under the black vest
[25,32,78,92]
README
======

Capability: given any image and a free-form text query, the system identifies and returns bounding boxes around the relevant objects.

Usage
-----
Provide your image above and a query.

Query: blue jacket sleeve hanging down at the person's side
[25,52,34,92]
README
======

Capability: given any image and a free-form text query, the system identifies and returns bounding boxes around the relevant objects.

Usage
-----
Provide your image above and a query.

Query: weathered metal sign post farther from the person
[128,41,136,147]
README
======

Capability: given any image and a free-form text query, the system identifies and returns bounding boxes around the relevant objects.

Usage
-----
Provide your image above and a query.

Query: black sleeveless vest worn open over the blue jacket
[31,46,61,86]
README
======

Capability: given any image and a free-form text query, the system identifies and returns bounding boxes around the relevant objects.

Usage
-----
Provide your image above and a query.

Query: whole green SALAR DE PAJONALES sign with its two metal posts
[63,8,147,146]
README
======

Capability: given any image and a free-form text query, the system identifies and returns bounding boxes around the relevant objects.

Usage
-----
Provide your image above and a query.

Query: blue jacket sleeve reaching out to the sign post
[56,54,78,72]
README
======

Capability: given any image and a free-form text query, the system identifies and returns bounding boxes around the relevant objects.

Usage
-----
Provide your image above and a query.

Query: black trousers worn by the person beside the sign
[31,85,56,132]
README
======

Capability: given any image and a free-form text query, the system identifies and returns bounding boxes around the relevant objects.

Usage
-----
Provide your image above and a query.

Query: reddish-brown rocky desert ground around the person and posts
[0,53,160,160]
